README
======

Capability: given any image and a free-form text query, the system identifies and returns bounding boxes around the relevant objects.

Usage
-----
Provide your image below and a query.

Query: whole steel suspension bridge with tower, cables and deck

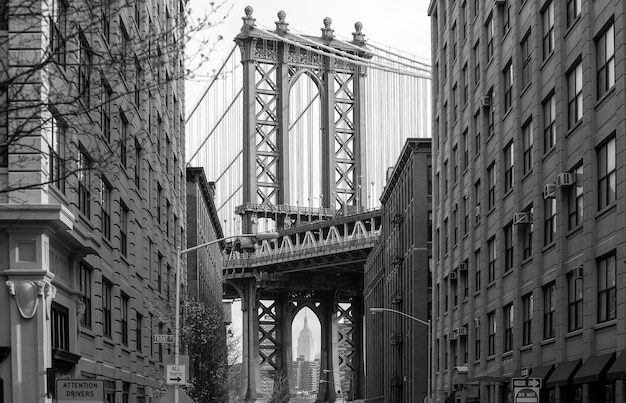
[186,7,431,401]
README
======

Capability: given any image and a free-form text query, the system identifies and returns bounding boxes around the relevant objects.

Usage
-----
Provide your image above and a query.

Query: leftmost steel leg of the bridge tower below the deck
[241,278,261,403]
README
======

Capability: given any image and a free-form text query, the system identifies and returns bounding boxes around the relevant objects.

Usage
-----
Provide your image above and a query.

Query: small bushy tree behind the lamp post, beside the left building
[181,300,229,403]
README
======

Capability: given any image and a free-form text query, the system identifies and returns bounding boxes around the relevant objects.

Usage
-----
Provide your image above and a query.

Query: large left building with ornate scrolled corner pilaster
[0,0,185,403]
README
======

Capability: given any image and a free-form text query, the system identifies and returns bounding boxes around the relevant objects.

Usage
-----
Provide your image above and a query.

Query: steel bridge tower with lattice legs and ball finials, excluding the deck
[229,6,372,402]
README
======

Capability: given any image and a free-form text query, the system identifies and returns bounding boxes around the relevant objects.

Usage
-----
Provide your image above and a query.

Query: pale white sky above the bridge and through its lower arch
[186,0,431,360]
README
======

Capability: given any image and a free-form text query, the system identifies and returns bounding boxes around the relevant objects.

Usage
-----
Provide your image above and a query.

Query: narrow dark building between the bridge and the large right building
[363,138,432,403]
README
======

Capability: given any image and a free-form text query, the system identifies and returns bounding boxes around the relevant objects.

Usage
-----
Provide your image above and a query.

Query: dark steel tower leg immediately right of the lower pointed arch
[316,292,341,402]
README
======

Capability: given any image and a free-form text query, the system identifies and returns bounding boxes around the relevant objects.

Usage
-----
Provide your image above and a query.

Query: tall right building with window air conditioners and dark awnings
[429,0,626,403]
